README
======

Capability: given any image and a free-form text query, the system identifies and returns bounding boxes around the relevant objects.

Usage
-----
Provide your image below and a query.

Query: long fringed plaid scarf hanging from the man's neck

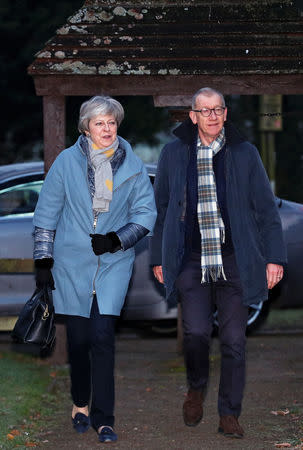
[197,128,226,283]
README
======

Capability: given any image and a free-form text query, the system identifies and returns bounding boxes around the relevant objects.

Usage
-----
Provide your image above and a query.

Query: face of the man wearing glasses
[189,94,227,145]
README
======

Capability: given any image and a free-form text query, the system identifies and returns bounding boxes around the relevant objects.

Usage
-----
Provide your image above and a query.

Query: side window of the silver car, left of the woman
[0,180,43,216]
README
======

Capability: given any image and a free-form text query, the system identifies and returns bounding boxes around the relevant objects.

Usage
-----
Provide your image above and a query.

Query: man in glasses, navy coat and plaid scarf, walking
[151,88,286,438]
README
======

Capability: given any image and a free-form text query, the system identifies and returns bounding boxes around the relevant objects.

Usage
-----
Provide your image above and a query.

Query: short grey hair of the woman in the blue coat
[78,95,124,133]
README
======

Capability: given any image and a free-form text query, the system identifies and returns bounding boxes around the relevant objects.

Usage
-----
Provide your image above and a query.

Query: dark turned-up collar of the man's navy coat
[173,117,246,145]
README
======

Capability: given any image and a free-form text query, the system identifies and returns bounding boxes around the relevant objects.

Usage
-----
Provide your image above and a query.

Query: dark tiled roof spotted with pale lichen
[28,0,303,77]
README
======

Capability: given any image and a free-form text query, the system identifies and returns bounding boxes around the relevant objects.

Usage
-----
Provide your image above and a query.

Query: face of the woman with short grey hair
[85,114,118,149]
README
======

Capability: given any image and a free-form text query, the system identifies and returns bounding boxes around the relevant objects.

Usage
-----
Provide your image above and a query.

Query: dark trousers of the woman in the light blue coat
[66,297,117,430]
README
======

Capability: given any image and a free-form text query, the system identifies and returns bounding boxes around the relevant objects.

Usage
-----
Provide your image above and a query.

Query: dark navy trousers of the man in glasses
[177,253,248,417]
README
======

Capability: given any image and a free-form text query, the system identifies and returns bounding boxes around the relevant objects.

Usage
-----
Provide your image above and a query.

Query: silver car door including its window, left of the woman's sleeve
[0,175,43,315]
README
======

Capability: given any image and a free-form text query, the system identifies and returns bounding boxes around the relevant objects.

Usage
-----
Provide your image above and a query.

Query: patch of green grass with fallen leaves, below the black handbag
[0,352,67,450]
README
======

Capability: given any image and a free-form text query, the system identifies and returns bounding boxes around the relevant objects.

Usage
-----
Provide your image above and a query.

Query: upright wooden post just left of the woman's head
[43,95,65,173]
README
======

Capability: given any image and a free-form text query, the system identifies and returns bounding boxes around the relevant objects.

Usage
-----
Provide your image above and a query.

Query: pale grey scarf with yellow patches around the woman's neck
[87,137,119,212]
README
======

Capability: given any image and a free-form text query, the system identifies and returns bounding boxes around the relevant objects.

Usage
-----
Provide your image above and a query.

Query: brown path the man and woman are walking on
[31,326,303,450]
